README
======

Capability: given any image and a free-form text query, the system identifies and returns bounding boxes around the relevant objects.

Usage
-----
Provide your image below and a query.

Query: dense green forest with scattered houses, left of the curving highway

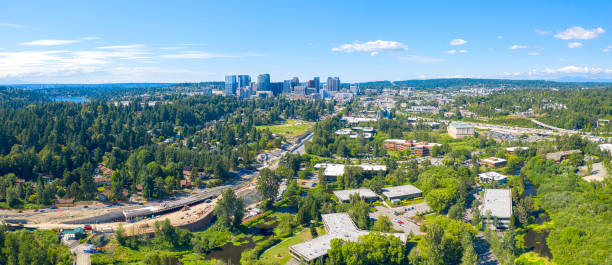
[0,93,332,208]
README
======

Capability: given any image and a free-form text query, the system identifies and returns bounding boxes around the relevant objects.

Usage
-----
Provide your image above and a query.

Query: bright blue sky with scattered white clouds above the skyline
[0,0,612,83]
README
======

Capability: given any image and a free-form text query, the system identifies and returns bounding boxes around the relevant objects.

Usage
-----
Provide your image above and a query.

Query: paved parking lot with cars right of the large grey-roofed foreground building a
[370,202,430,235]
